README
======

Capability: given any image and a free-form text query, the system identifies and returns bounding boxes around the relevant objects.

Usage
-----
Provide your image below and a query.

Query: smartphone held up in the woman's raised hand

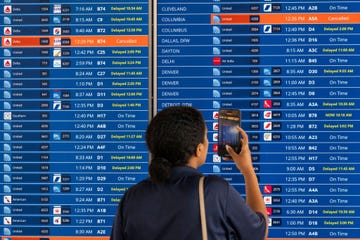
[218,109,241,157]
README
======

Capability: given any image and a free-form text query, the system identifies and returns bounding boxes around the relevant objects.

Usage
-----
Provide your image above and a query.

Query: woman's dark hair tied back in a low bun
[146,106,206,182]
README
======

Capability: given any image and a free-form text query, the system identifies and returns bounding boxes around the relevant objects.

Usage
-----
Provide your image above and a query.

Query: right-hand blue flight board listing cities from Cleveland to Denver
[156,0,360,239]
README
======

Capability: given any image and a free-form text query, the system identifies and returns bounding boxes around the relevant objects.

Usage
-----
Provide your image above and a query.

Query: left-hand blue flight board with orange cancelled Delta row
[0,0,150,240]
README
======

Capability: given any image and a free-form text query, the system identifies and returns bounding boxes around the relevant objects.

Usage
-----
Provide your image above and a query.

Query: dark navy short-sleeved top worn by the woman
[110,166,266,240]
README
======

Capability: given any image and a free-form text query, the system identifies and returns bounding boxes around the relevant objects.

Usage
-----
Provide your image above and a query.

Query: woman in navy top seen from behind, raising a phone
[110,107,267,240]
